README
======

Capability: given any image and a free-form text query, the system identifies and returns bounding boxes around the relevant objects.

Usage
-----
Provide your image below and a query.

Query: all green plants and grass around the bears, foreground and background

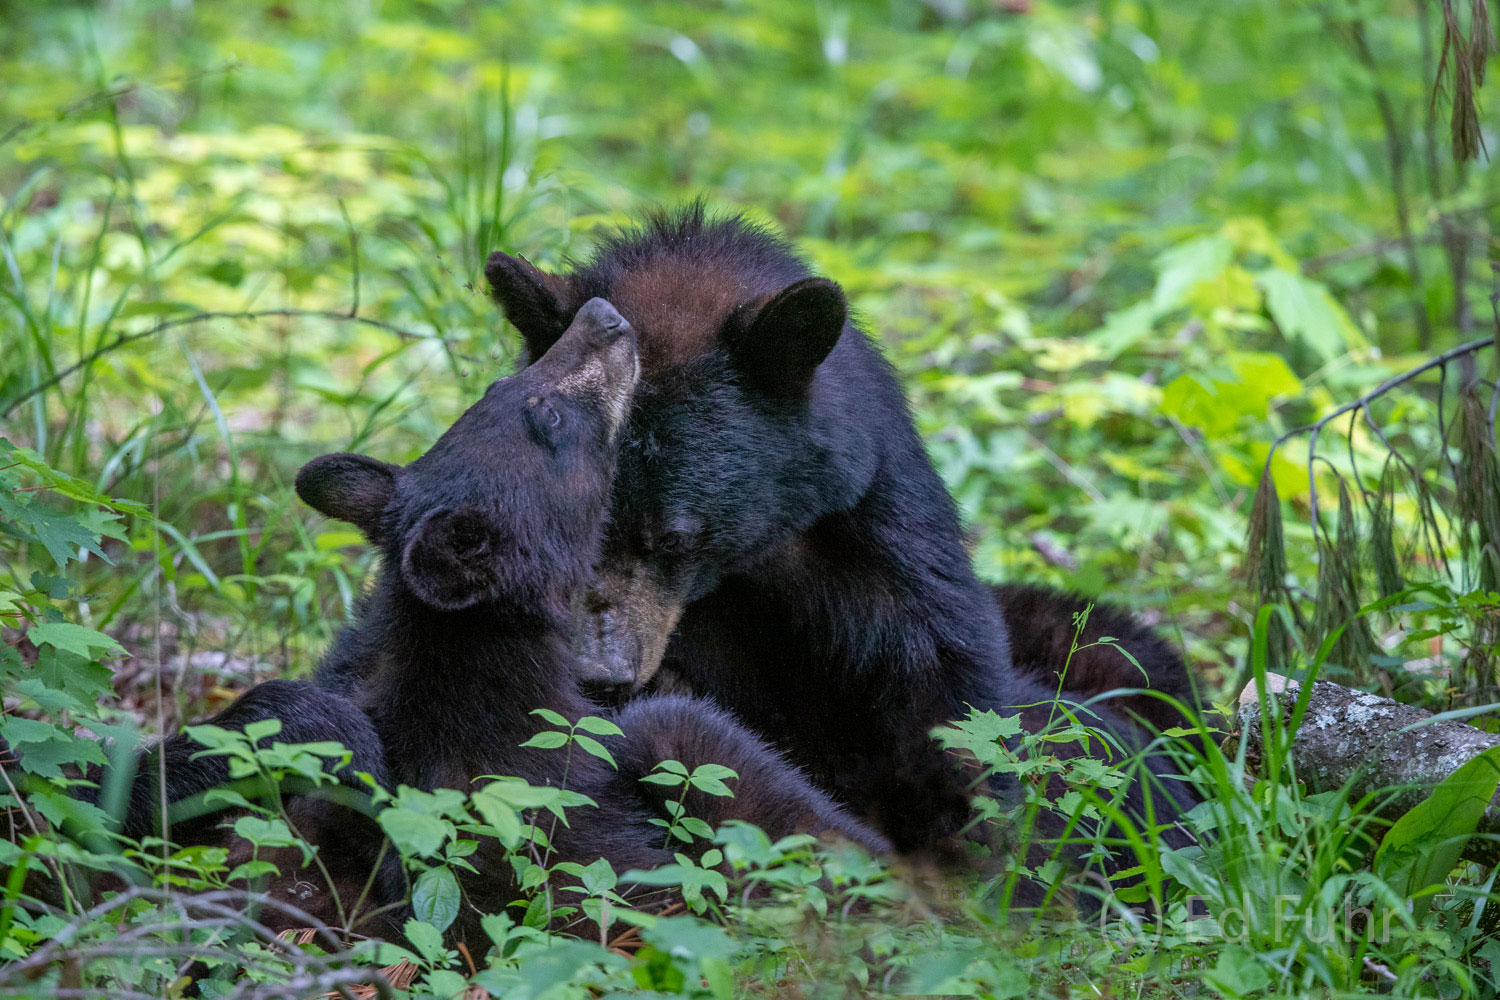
[0,0,1500,999]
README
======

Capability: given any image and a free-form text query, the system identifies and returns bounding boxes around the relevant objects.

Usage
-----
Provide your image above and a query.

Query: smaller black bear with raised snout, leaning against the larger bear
[297,300,888,940]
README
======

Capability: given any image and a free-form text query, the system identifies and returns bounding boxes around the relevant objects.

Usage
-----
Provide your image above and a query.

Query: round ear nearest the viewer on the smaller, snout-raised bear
[401,507,513,612]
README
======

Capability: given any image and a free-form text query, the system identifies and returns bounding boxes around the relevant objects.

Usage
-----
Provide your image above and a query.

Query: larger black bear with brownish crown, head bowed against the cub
[486,205,1187,852]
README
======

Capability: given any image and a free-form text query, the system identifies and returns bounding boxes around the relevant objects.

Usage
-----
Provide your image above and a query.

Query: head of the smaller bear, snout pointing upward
[297,298,641,615]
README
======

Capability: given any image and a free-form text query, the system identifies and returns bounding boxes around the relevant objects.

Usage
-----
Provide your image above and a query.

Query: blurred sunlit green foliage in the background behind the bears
[0,0,1500,721]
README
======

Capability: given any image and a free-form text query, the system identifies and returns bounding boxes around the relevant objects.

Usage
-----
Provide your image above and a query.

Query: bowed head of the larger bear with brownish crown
[486,207,876,685]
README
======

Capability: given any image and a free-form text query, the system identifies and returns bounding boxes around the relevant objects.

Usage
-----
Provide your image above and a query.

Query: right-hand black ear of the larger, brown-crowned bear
[725,277,849,396]
